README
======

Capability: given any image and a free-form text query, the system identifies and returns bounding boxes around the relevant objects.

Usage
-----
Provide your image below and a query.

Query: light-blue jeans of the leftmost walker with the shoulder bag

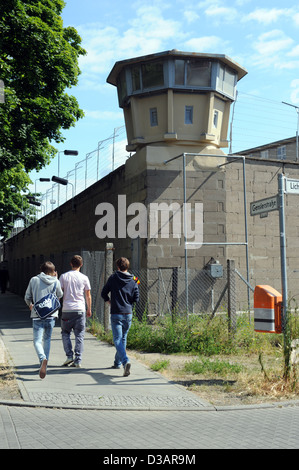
[32,317,55,363]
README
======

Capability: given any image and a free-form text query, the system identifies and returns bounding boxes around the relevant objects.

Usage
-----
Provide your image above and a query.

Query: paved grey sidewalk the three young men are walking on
[0,292,215,411]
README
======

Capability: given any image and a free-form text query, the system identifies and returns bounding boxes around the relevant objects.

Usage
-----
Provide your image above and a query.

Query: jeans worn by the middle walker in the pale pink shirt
[61,312,85,363]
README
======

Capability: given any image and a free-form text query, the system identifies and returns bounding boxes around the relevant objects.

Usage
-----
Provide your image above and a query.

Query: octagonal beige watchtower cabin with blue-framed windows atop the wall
[107,50,247,162]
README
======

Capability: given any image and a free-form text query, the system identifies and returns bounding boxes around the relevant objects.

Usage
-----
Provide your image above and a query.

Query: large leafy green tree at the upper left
[0,0,86,235]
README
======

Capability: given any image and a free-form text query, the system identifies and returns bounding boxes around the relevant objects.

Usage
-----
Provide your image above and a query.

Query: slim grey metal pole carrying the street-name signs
[278,173,288,333]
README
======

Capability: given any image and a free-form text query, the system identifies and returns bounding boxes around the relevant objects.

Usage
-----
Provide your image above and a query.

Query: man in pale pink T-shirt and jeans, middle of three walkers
[59,255,91,367]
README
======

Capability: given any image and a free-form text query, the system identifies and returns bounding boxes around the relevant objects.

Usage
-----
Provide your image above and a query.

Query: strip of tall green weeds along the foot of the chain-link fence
[90,314,299,356]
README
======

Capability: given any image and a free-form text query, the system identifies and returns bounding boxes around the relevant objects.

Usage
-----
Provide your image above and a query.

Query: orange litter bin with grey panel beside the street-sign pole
[254,285,282,333]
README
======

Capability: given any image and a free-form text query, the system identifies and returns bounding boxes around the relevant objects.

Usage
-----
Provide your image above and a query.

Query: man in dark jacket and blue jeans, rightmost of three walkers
[101,258,139,377]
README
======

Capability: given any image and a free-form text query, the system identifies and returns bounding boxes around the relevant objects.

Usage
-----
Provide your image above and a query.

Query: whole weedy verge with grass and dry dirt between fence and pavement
[90,314,299,405]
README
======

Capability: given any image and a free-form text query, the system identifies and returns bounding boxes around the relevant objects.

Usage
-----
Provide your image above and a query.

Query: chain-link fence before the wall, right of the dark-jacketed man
[96,260,299,327]
